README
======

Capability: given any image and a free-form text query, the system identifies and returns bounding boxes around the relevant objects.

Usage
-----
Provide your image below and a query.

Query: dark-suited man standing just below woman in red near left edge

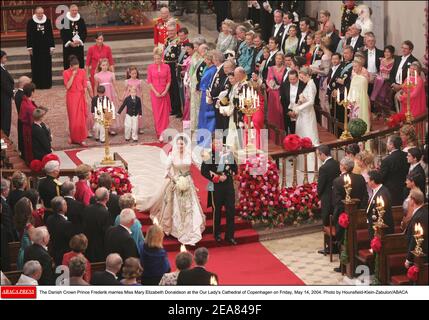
[31,109,52,160]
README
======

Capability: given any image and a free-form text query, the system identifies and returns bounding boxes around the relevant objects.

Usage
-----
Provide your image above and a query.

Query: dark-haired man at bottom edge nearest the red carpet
[177,247,219,286]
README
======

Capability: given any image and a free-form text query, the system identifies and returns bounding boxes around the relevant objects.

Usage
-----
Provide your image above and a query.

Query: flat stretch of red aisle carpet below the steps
[169,242,305,286]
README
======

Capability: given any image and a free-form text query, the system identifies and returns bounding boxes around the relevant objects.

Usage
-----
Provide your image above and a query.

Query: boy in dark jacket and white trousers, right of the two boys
[118,87,142,142]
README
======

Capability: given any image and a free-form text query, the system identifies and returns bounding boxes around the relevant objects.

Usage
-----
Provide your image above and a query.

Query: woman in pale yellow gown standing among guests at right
[348,57,371,132]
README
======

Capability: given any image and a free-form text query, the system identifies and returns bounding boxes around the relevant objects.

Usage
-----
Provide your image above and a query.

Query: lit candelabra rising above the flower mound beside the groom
[238,88,260,153]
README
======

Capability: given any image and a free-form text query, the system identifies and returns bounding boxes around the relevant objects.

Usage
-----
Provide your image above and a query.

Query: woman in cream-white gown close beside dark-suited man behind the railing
[292,67,319,170]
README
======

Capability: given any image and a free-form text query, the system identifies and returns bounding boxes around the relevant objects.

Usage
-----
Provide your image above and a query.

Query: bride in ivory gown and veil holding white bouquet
[150,135,206,246]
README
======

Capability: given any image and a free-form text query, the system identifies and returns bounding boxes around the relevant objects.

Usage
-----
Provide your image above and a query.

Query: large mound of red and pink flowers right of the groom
[236,155,319,228]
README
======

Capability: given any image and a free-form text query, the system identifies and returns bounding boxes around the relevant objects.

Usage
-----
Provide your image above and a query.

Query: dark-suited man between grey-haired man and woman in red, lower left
[46,197,80,266]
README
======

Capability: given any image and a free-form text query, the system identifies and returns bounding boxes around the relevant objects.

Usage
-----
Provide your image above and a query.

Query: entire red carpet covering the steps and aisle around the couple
[65,144,304,285]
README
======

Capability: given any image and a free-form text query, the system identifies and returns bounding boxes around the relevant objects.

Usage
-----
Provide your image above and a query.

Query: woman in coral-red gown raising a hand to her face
[63,56,88,146]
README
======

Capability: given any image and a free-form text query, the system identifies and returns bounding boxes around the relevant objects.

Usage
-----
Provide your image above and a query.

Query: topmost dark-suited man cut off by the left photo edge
[0,50,15,137]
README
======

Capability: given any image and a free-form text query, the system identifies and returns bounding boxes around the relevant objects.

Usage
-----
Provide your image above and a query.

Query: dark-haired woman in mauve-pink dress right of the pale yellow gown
[371,46,395,108]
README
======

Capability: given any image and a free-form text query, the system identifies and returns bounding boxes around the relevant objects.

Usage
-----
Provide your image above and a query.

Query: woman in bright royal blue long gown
[198,52,217,146]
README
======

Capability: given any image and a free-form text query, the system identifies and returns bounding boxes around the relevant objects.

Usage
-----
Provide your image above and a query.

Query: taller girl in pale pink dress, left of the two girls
[94,59,119,135]
